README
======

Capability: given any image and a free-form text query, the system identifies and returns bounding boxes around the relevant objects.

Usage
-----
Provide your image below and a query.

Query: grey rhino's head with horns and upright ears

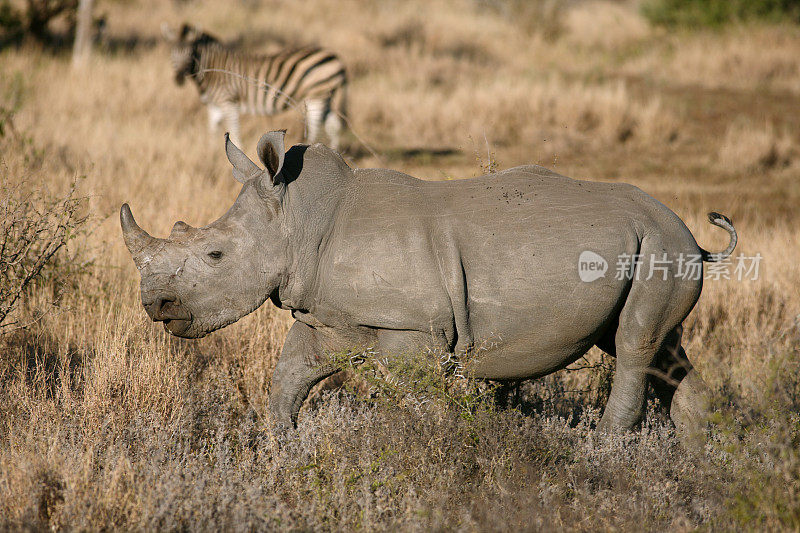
[120,131,288,338]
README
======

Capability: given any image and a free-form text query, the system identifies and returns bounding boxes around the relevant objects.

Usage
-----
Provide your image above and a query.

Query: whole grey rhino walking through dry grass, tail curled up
[120,131,736,438]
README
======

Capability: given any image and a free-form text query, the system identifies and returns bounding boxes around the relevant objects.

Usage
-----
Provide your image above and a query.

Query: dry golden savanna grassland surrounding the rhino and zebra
[0,0,800,530]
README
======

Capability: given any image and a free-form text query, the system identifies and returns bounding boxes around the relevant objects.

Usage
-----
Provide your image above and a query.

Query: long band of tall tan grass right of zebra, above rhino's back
[355,75,678,157]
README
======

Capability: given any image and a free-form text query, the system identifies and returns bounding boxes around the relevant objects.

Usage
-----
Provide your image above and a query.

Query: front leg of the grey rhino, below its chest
[269,322,337,433]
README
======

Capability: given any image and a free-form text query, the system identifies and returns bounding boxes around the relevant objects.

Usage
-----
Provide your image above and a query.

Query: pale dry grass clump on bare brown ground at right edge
[717,120,797,172]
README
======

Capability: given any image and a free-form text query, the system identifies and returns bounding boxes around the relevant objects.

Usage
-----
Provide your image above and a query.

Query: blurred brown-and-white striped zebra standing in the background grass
[162,24,347,150]
